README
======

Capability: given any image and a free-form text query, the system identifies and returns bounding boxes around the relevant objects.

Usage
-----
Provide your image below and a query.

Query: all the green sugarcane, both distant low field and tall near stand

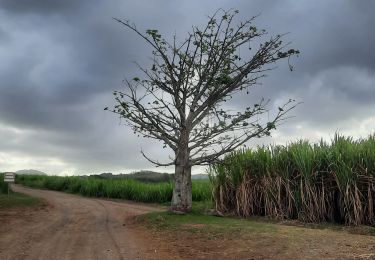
[13,135,375,226]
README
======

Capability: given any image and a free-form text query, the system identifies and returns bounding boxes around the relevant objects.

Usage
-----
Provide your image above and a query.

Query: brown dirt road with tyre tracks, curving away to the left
[0,185,169,260]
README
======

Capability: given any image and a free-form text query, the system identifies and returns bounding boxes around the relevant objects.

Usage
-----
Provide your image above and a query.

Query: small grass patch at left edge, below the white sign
[0,192,41,210]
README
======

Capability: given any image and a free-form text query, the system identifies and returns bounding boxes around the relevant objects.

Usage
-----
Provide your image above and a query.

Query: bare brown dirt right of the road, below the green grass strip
[134,215,375,260]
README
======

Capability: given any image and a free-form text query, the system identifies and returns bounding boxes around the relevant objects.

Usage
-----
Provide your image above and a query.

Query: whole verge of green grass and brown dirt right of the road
[134,209,375,259]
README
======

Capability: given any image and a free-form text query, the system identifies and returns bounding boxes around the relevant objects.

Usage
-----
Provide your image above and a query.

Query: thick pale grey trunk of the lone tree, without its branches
[171,131,192,212]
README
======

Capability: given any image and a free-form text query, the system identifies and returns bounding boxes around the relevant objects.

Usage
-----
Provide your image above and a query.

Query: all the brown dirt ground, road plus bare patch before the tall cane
[0,186,375,260]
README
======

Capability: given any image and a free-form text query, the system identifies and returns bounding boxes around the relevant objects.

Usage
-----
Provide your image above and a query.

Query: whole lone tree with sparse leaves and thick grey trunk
[105,10,299,212]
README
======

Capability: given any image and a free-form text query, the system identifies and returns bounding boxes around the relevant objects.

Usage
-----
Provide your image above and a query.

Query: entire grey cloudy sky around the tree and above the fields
[0,0,375,175]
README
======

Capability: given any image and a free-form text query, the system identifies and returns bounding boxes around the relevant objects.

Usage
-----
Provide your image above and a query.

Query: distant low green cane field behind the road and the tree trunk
[16,175,212,203]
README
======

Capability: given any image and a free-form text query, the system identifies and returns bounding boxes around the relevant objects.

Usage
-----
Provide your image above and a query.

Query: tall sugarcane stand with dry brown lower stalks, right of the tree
[211,135,375,225]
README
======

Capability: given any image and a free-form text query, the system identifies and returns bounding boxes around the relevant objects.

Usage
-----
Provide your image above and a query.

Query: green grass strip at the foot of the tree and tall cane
[136,201,375,239]
